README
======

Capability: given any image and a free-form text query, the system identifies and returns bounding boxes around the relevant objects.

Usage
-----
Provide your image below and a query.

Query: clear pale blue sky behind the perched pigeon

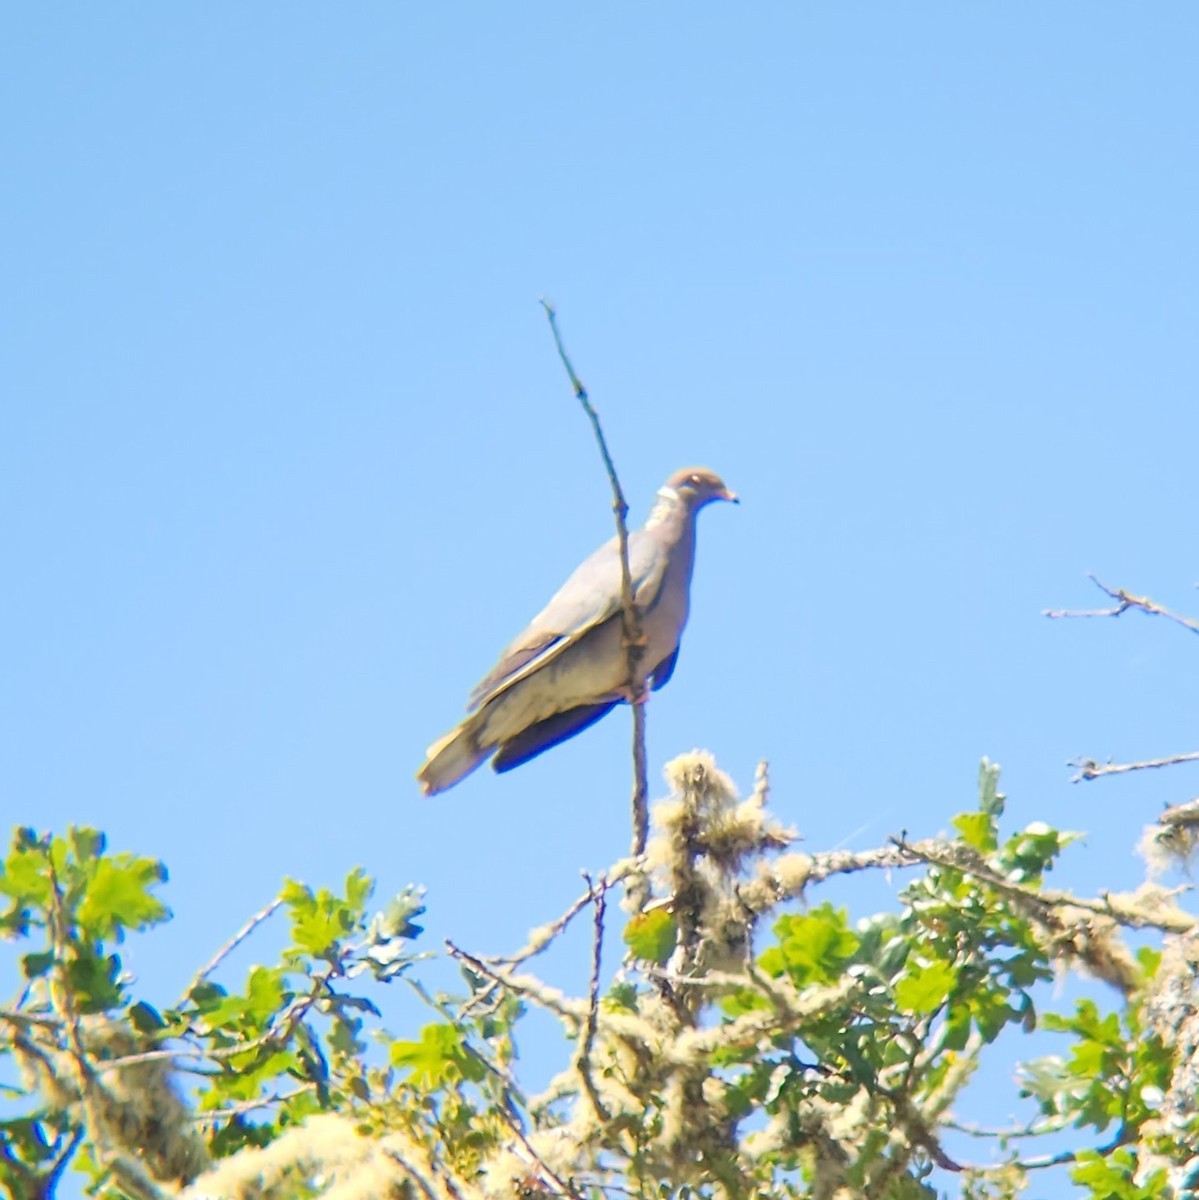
[0,0,1199,1190]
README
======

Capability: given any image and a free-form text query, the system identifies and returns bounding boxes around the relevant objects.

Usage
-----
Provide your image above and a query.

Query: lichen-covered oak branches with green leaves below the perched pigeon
[0,752,1199,1200]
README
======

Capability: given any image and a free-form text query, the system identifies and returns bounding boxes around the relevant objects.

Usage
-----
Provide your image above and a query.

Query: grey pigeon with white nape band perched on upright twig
[416,467,738,796]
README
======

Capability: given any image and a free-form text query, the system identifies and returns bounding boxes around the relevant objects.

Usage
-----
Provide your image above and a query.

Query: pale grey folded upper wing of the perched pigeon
[467,529,670,712]
